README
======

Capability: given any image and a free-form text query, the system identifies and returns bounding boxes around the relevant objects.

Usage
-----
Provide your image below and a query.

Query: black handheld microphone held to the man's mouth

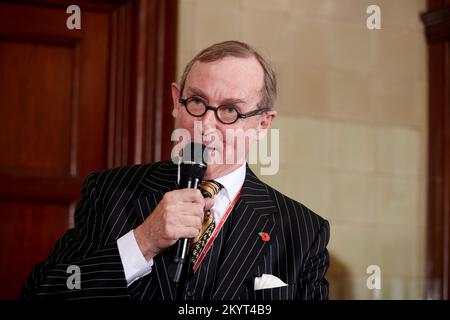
[172,142,208,283]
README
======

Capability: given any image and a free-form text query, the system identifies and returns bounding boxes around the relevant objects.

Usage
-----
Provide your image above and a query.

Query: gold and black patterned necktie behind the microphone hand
[190,180,223,268]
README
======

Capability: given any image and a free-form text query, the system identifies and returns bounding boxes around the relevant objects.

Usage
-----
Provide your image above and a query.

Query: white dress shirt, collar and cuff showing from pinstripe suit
[117,163,246,285]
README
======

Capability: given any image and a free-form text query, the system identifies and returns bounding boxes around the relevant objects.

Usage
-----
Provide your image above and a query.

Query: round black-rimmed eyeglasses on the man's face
[178,97,270,124]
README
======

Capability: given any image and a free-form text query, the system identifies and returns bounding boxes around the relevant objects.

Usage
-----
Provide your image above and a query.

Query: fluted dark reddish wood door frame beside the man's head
[108,0,177,167]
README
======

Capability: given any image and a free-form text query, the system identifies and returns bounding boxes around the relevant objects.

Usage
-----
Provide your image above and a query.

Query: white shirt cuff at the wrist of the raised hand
[117,230,153,286]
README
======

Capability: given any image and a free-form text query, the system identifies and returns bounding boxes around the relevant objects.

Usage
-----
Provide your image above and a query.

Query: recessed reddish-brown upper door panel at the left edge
[0,40,73,176]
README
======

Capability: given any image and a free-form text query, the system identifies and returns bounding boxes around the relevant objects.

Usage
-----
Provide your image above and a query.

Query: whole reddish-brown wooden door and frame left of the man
[0,0,177,299]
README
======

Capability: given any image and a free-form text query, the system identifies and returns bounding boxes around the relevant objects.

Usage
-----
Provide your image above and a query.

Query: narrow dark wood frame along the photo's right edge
[421,0,450,299]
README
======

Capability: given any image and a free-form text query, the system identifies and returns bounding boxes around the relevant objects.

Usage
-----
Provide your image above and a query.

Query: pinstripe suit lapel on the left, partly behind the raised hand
[133,162,178,300]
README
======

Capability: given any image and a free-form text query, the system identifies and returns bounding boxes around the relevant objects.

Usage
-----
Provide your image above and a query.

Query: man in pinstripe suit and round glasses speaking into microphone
[21,41,329,300]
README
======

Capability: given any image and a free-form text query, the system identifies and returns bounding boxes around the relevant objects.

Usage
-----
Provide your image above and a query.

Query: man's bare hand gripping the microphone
[134,189,214,261]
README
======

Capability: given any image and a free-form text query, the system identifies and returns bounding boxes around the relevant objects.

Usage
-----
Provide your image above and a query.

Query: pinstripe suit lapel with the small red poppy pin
[212,166,277,300]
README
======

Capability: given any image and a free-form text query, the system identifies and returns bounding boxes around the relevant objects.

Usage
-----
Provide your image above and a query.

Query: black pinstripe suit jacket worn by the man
[20,162,329,300]
